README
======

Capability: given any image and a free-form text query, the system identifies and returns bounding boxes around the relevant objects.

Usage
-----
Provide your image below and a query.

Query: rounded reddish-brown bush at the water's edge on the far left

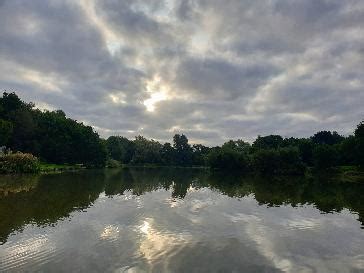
[0,152,40,174]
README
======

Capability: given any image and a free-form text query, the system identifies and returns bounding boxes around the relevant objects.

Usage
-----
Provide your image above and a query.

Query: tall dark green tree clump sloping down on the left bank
[0,92,106,167]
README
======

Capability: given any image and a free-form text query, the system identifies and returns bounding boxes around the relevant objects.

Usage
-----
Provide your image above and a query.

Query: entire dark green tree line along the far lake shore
[0,92,364,174]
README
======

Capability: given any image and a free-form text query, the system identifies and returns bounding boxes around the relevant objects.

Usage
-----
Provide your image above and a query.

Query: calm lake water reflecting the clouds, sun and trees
[0,169,364,273]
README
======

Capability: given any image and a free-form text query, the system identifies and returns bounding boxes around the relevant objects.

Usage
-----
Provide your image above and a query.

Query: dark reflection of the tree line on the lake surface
[0,168,364,243]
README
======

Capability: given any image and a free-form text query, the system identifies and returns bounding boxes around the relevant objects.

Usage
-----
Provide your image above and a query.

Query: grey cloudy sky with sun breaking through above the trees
[0,0,364,145]
